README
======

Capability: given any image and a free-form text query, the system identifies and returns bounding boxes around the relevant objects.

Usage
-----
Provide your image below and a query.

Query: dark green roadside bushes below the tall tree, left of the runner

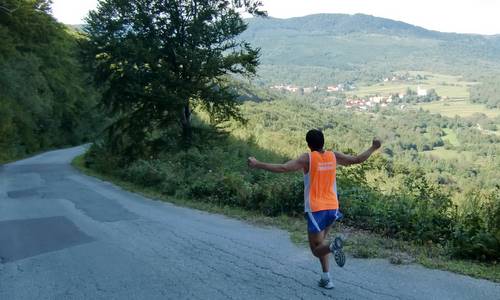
[85,128,303,216]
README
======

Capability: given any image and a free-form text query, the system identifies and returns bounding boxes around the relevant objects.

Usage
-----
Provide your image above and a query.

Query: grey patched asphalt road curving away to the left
[0,147,500,300]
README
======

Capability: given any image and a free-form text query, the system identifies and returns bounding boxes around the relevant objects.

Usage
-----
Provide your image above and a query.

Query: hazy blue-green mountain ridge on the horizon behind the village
[242,14,500,83]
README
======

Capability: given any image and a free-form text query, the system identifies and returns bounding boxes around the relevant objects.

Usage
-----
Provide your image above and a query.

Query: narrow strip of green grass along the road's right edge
[71,155,500,282]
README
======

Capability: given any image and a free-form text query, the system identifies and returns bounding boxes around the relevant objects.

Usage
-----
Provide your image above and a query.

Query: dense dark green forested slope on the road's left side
[0,0,98,162]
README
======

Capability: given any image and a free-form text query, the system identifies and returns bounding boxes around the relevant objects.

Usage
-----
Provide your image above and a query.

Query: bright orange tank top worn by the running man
[304,151,339,212]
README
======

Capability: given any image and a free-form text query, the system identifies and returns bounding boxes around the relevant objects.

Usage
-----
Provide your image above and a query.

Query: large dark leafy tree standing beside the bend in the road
[84,0,265,149]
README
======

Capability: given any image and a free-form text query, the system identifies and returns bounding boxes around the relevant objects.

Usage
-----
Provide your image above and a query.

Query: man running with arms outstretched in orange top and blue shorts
[248,129,381,289]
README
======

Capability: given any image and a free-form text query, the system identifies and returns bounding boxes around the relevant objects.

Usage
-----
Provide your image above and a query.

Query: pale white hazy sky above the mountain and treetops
[52,0,500,34]
